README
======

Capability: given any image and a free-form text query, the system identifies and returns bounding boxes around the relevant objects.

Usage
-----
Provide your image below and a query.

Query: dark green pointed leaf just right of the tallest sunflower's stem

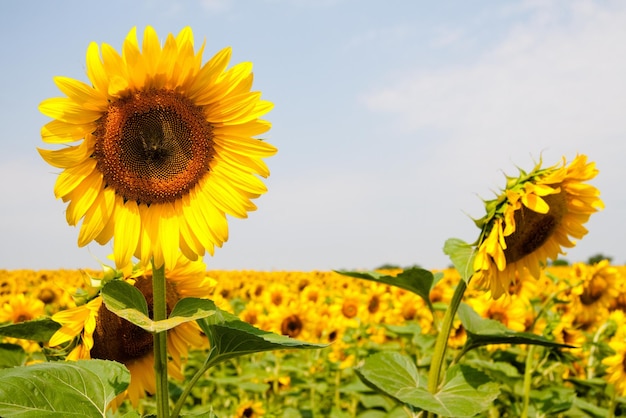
[198,309,328,366]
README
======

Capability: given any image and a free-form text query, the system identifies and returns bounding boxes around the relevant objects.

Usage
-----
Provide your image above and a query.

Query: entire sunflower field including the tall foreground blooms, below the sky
[0,26,626,418]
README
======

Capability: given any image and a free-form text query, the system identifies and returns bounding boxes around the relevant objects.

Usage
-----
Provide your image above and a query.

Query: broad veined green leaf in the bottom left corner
[0,360,130,418]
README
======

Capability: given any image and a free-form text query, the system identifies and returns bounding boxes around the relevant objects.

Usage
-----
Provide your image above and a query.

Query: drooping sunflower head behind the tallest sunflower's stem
[49,256,215,407]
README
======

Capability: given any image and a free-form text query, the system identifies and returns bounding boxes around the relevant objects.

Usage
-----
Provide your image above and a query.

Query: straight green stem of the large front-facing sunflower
[152,260,169,418]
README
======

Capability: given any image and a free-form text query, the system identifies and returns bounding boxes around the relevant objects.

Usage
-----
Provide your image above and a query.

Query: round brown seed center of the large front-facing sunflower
[92,90,215,205]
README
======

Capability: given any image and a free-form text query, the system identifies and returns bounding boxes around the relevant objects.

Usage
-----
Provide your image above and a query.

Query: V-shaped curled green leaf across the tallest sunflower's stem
[102,280,216,333]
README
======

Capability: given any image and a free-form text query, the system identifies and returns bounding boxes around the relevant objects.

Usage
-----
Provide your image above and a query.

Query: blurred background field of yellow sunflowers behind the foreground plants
[0,260,626,418]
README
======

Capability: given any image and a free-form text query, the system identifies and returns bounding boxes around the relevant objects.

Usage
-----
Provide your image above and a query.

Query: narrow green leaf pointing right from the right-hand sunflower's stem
[458,303,573,351]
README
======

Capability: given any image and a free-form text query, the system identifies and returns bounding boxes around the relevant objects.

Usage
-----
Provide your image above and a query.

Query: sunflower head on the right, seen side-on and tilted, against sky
[474,155,603,299]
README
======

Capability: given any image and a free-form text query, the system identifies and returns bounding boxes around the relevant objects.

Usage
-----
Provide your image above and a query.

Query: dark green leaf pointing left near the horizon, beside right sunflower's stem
[336,267,443,311]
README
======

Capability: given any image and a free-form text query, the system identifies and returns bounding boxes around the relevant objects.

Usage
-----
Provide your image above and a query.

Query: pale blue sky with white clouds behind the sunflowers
[0,0,626,271]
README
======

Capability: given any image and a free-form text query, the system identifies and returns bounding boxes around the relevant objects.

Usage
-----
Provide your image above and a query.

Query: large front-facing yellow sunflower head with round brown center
[39,26,276,268]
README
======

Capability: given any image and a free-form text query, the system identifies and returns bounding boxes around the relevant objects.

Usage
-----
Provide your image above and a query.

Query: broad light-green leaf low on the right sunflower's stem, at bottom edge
[356,352,499,418]
